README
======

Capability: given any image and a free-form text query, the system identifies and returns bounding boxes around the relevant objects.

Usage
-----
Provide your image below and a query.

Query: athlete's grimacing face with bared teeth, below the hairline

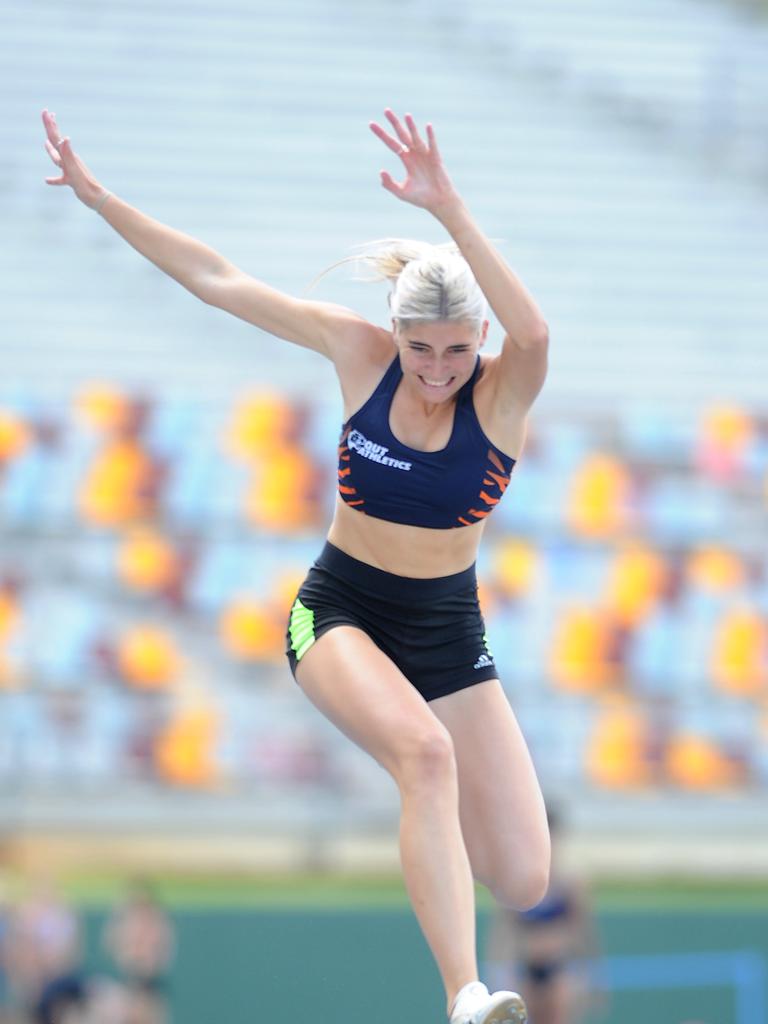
[392,321,488,402]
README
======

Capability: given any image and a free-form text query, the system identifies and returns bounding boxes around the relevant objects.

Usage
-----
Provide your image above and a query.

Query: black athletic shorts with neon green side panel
[286,542,497,700]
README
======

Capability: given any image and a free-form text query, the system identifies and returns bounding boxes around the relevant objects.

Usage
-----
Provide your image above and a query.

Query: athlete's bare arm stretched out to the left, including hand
[43,111,371,361]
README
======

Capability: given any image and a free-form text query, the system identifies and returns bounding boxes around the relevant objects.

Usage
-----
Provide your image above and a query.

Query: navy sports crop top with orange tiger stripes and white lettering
[339,354,516,529]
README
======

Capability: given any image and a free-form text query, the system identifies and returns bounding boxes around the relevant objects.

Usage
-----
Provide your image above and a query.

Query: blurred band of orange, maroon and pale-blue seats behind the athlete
[0,388,768,806]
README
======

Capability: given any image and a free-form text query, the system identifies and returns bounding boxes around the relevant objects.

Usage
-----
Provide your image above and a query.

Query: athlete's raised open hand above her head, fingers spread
[370,108,459,213]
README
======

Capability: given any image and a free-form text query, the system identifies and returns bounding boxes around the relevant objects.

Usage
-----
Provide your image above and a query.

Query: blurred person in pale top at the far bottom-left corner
[8,877,85,1024]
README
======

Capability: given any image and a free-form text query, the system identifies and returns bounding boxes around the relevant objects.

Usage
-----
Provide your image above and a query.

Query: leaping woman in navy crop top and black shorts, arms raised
[43,110,550,1024]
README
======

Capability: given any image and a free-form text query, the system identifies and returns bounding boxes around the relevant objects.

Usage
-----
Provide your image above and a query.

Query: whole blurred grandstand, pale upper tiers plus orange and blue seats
[0,0,768,847]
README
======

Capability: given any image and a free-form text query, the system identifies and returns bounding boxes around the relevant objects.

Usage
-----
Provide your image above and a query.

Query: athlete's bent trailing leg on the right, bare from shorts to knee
[429,679,550,910]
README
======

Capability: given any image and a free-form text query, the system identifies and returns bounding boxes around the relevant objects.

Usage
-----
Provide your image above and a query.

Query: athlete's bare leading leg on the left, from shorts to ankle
[296,626,477,1007]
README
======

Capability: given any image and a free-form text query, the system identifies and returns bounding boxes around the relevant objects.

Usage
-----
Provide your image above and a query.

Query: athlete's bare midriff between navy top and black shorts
[328,495,484,580]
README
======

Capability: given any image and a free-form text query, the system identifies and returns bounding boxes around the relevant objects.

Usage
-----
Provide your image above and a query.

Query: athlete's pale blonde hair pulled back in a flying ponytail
[313,239,487,331]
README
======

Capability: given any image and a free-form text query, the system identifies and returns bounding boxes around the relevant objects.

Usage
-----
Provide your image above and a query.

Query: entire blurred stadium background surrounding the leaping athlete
[0,0,768,1024]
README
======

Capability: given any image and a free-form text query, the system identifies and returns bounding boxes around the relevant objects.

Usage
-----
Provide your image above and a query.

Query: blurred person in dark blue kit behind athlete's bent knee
[486,808,603,1024]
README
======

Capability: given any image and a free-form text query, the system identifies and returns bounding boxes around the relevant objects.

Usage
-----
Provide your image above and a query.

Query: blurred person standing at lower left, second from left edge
[102,880,175,1024]
